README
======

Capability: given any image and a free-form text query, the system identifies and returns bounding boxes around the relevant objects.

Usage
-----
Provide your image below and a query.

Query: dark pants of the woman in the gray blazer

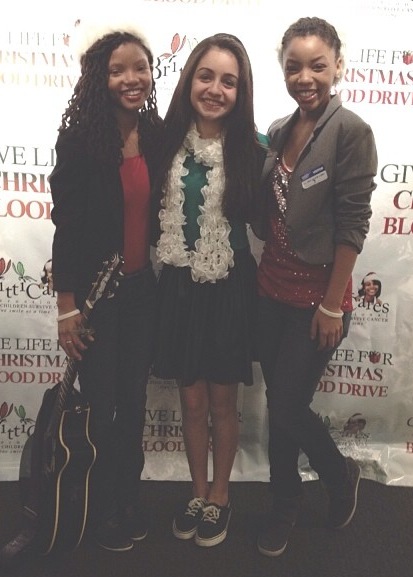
[257,297,351,498]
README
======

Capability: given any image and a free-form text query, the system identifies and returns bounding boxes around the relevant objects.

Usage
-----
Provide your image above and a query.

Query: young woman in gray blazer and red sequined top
[253,18,377,557]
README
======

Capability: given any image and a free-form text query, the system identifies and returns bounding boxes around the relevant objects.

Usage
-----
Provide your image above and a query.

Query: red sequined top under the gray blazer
[258,161,353,312]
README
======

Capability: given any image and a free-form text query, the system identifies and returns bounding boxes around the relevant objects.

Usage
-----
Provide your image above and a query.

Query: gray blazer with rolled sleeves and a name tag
[251,95,377,264]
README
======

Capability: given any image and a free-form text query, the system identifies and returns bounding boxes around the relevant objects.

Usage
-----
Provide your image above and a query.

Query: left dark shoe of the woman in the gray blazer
[257,496,302,557]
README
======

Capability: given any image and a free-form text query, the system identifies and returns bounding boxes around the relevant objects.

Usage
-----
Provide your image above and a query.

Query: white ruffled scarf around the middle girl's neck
[156,125,234,282]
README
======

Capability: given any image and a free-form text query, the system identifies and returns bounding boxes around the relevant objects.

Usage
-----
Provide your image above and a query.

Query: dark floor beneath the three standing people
[0,480,413,577]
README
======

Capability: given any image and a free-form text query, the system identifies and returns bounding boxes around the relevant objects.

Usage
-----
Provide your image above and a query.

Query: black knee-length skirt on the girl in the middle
[153,249,257,386]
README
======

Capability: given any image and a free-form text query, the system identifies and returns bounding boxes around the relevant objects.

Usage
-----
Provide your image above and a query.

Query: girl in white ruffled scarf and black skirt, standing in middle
[154,34,266,547]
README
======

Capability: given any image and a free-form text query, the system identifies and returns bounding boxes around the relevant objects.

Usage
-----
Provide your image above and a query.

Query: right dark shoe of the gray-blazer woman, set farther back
[327,457,361,529]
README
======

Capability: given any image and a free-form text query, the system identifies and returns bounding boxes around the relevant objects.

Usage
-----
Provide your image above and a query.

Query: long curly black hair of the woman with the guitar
[59,31,161,164]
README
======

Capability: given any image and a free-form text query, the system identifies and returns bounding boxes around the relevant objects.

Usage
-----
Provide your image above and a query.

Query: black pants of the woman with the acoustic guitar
[79,267,156,523]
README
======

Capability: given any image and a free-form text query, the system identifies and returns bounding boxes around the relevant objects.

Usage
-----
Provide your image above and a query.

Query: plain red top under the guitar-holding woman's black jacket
[120,155,150,274]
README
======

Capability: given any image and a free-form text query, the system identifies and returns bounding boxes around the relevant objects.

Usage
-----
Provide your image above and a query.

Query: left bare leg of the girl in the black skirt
[179,381,209,499]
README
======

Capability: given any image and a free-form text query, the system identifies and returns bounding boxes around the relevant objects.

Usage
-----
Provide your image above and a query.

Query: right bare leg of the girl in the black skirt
[208,383,239,506]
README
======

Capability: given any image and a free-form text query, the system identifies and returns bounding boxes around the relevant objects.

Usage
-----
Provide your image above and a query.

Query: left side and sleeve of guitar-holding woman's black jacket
[50,130,124,295]
